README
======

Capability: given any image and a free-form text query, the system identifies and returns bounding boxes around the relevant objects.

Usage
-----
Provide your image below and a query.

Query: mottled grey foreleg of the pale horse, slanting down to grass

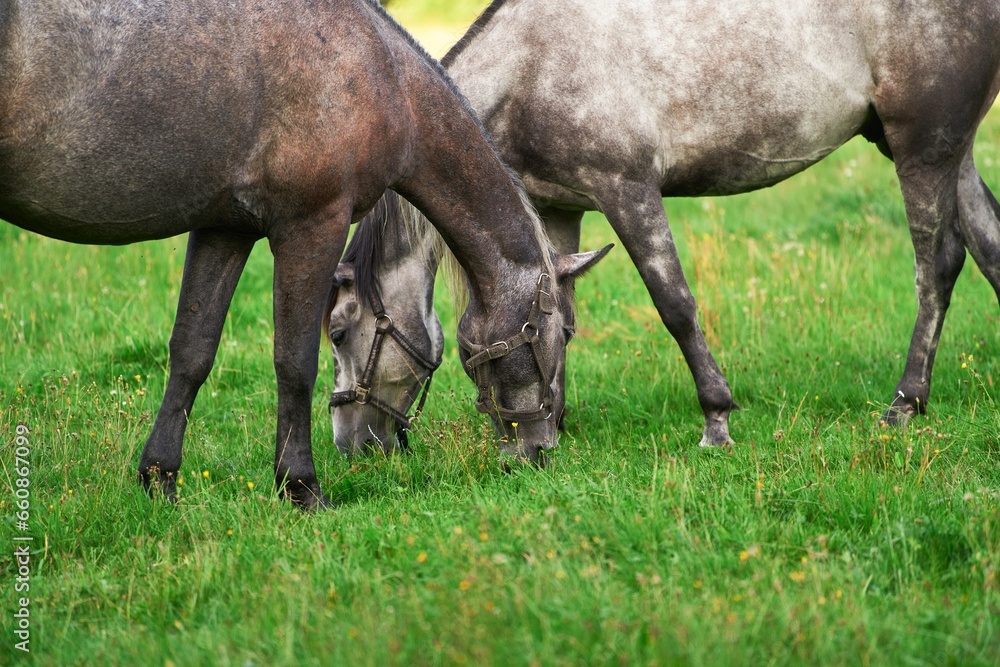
[598,184,739,447]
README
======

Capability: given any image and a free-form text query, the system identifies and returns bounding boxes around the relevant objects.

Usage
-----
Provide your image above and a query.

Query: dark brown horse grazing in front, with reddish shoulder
[0,0,596,507]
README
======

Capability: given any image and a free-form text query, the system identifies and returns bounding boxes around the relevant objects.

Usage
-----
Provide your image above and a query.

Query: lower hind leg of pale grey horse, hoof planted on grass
[883,163,965,426]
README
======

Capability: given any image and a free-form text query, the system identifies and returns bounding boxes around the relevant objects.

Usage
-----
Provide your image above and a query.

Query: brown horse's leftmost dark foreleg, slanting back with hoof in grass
[139,230,254,500]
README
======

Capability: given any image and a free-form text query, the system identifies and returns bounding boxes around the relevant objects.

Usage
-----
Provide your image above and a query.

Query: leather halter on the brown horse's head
[458,273,555,422]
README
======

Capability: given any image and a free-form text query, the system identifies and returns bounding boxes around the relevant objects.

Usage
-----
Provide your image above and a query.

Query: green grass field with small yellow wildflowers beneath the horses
[0,2,1000,666]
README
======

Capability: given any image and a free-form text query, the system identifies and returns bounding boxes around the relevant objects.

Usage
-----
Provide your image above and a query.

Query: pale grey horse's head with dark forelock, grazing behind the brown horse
[324,191,444,455]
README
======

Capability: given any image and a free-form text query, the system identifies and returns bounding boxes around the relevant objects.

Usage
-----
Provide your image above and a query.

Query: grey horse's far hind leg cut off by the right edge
[958,150,1000,299]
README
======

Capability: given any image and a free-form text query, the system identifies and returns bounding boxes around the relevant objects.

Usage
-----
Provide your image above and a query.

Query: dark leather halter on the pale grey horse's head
[329,295,441,438]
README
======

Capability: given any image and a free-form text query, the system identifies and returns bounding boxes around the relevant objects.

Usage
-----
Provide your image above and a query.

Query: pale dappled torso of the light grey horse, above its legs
[449,0,997,202]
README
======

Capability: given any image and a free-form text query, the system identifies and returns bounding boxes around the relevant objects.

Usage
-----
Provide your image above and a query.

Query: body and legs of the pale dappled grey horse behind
[328,0,1000,452]
